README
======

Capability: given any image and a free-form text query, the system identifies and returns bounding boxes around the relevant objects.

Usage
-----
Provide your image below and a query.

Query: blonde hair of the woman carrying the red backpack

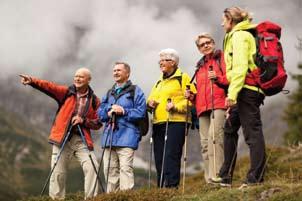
[223,6,253,24]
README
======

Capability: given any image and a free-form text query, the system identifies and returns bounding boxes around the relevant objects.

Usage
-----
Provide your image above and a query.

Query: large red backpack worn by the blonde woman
[245,21,287,96]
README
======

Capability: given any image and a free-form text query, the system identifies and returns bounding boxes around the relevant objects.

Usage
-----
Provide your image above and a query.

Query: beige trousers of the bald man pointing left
[49,135,99,199]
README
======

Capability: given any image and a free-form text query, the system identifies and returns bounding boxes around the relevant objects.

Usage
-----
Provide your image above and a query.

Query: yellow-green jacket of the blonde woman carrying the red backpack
[223,20,263,101]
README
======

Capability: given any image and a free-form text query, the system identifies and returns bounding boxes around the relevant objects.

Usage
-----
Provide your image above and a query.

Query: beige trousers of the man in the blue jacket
[103,147,134,193]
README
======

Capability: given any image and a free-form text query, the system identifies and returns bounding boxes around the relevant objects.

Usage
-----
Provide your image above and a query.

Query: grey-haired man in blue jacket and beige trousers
[98,62,146,193]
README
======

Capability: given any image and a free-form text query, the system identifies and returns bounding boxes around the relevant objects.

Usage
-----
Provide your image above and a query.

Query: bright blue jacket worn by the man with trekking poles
[98,80,146,149]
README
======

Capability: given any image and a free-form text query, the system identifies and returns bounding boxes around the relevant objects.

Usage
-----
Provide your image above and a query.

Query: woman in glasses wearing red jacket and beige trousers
[191,33,228,183]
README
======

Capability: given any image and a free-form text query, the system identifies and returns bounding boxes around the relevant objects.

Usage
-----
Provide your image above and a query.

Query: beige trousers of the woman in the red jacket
[199,109,225,182]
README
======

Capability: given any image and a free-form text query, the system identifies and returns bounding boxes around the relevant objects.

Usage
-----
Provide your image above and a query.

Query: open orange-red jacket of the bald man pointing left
[31,78,102,150]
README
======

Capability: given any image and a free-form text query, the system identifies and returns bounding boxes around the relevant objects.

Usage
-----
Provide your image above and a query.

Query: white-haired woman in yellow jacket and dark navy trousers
[147,49,196,188]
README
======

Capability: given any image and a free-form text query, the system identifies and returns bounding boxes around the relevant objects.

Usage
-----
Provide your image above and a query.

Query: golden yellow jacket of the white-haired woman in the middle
[147,68,196,124]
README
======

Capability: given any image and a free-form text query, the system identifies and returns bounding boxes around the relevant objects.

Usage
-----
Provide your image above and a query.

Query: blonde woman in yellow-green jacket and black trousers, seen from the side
[219,7,265,188]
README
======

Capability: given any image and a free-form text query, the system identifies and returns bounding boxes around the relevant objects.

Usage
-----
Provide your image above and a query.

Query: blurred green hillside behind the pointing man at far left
[0,107,91,201]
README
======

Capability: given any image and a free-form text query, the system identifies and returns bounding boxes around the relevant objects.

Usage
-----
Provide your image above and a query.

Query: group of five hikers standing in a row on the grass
[20,7,274,199]
